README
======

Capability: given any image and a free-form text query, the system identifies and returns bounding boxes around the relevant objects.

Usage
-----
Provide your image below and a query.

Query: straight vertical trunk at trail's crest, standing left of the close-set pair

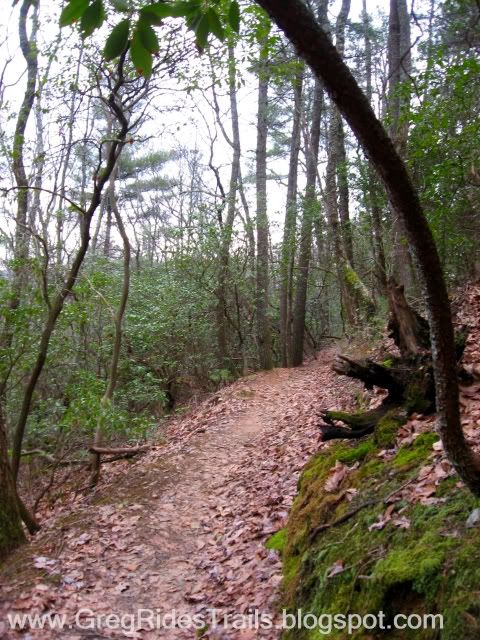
[256,46,273,369]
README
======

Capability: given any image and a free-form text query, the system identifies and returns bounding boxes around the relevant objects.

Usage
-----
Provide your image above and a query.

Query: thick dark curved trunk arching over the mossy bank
[257,0,480,495]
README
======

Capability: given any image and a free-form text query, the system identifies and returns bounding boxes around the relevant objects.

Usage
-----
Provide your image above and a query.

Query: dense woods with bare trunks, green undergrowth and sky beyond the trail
[0,0,480,576]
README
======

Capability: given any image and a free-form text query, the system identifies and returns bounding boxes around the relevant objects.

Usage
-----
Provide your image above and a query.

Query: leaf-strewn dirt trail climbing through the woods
[0,350,354,640]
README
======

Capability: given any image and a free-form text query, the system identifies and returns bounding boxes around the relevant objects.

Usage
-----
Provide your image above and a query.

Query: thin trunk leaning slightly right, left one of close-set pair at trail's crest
[280,66,304,367]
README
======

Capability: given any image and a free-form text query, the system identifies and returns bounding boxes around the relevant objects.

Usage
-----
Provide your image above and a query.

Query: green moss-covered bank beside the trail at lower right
[268,425,480,640]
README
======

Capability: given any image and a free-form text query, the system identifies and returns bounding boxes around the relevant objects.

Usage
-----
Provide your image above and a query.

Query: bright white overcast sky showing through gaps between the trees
[0,0,389,252]
